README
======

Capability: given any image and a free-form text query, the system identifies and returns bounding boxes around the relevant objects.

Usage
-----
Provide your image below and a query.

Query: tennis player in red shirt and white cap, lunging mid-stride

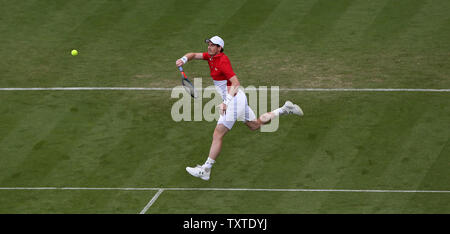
[176,36,303,180]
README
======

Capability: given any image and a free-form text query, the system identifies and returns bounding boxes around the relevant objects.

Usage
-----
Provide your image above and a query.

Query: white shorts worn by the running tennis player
[217,89,256,130]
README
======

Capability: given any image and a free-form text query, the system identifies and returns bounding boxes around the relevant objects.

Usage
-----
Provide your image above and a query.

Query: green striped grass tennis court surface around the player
[0,0,450,214]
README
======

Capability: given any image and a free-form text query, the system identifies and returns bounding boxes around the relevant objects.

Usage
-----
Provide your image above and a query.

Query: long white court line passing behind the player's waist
[0,86,450,92]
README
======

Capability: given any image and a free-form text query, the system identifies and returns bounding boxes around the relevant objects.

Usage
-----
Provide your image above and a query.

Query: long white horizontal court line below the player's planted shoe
[0,187,450,193]
